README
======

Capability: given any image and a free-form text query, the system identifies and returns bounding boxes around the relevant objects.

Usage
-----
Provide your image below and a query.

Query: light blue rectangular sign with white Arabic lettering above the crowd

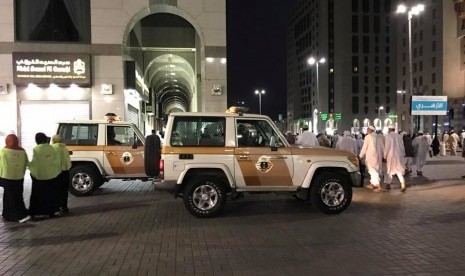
[412,96,447,115]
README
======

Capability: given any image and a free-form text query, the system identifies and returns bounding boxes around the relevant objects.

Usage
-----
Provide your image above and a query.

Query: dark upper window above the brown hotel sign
[15,0,91,43]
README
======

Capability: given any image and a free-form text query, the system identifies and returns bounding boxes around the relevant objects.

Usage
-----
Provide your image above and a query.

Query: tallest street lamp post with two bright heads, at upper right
[396,4,425,132]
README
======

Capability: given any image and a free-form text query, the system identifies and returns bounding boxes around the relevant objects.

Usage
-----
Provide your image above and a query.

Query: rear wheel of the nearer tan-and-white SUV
[183,176,226,218]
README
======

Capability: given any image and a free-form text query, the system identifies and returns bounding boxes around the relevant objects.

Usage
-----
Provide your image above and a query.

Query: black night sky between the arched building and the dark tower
[226,0,296,120]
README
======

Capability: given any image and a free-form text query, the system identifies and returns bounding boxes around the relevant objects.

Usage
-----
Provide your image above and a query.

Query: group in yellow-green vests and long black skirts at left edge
[0,132,71,223]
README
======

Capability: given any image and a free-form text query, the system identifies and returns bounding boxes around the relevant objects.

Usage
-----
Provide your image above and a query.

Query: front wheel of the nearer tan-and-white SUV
[310,172,352,214]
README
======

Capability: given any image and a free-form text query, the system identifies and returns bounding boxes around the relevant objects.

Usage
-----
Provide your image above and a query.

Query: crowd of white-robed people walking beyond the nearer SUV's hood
[286,125,436,192]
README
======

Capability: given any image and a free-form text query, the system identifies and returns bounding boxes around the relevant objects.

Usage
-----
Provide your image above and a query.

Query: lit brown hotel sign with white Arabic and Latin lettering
[13,52,91,86]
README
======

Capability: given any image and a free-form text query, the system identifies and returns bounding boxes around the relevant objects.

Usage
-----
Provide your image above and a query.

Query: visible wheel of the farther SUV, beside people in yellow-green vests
[69,165,103,196]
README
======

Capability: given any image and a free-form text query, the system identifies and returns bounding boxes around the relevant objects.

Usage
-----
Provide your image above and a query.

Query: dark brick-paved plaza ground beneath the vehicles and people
[0,156,465,275]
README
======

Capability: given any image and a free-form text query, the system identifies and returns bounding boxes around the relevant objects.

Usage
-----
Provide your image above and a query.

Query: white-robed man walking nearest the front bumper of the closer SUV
[359,126,381,192]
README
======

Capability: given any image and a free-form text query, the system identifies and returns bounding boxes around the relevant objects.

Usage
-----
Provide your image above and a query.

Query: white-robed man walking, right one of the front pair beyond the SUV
[384,126,407,192]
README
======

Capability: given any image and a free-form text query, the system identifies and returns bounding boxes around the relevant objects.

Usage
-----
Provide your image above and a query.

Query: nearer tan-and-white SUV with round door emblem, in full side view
[159,108,360,217]
